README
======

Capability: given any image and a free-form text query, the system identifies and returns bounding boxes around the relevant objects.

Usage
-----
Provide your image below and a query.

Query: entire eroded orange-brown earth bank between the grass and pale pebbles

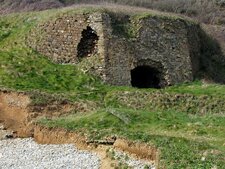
[0,91,159,168]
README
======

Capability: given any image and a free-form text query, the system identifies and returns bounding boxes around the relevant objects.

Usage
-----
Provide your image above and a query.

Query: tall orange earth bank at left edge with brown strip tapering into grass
[0,91,77,137]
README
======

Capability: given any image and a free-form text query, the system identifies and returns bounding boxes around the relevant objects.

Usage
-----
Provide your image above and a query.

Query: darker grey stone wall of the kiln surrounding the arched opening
[103,17,199,87]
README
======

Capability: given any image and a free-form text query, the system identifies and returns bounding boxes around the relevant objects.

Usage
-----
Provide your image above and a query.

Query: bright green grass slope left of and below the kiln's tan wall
[0,10,105,96]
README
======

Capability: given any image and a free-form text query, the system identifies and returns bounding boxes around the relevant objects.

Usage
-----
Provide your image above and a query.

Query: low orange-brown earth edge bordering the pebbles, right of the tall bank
[34,126,159,169]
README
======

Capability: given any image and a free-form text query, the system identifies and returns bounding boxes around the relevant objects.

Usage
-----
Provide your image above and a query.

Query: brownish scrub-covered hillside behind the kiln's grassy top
[0,0,225,24]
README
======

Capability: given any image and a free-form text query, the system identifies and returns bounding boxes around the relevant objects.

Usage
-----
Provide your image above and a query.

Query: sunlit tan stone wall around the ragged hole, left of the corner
[27,12,107,79]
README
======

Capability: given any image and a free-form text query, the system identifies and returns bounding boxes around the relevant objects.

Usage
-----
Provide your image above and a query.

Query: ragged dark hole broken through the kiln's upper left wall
[77,26,98,58]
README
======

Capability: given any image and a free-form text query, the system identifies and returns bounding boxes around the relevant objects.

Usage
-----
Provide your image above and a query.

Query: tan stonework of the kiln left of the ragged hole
[29,15,88,63]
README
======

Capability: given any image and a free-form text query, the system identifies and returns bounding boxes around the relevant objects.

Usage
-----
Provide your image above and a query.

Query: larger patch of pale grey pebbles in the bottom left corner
[0,138,100,169]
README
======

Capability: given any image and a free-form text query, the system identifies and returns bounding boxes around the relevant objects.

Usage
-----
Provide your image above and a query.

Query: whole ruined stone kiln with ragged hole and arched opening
[27,11,200,88]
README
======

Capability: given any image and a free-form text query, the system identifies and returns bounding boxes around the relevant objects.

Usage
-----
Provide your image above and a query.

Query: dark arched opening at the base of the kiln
[131,66,161,88]
